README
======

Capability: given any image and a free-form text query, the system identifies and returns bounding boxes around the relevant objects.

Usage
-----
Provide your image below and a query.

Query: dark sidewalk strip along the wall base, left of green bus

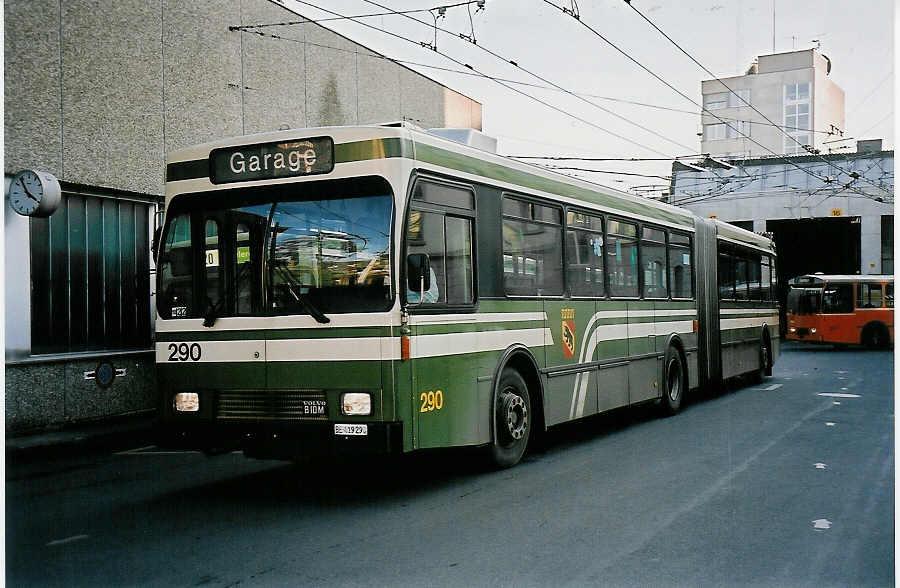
[6,412,156,463]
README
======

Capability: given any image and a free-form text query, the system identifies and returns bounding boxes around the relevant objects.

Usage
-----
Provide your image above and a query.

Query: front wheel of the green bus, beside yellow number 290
[489,368,532,468]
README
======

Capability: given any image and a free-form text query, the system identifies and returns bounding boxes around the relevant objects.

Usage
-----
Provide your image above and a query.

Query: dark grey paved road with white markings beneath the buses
[6,346,894,588]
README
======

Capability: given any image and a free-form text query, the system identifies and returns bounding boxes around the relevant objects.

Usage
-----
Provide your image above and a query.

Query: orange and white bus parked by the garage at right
[787,274,894,348]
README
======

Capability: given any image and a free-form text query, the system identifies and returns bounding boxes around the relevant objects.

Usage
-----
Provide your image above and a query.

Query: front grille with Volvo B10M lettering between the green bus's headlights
[216,390,328,421]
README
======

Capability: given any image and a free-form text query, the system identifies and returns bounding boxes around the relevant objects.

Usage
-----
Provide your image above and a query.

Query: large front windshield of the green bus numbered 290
[157,178,393,322]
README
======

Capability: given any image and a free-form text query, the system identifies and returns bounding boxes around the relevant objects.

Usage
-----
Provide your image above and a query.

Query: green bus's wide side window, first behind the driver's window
[503,197,563,296]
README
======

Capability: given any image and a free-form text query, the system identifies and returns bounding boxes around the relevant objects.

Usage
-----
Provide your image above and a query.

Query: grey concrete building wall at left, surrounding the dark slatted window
[4,0,482,433]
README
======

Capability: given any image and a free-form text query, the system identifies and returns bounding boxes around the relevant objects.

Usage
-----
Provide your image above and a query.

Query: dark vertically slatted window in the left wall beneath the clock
[30,193,152,354]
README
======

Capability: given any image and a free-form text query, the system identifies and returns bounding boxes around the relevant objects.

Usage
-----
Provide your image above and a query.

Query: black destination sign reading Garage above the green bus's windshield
[209,137,334,184]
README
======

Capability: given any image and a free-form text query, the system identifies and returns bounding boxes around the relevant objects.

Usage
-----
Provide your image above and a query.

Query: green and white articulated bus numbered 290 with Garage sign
[156,123,779,467]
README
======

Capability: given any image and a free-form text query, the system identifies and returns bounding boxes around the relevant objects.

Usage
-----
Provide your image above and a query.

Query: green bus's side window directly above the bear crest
[566,211,606,296]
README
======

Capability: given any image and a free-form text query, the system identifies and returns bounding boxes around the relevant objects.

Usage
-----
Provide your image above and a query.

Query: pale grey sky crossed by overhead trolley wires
[285,0,894,193]
